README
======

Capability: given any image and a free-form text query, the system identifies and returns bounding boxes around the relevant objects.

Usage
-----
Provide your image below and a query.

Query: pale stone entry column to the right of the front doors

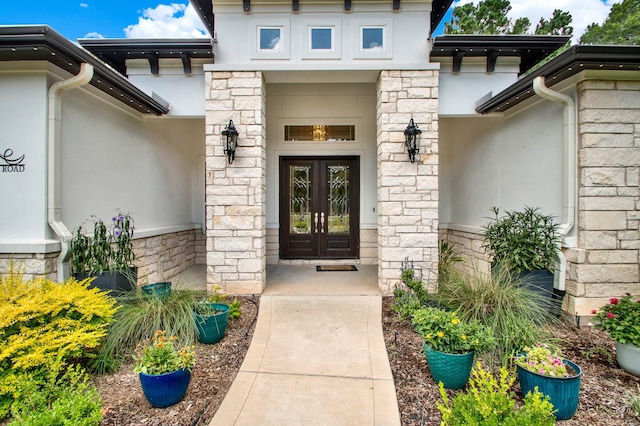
[376,70,438,294]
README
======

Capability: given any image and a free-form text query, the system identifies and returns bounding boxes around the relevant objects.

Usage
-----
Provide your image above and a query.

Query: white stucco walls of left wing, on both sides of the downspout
[0,62,205,253]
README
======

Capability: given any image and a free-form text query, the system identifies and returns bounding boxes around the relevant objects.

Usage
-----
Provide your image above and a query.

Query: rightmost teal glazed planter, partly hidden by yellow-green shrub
[517,359,582,420]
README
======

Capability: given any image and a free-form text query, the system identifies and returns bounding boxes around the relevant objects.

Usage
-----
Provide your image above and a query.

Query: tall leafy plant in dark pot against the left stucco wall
[70,212,137,291]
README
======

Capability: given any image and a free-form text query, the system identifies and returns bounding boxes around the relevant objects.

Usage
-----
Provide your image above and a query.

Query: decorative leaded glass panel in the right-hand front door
[327,166,349,234]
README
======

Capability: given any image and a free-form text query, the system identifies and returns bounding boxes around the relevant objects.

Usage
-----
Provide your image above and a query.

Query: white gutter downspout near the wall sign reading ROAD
[47,63,93,281]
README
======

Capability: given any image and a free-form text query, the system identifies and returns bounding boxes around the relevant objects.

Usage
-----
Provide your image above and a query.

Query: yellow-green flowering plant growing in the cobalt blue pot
[133,330,196,374]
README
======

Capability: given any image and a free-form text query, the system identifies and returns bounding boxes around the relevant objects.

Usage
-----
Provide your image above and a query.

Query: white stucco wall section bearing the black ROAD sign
[0,62,49,245]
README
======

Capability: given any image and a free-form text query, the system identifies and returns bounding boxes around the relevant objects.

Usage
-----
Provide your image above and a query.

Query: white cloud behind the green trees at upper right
[452,0,622,43]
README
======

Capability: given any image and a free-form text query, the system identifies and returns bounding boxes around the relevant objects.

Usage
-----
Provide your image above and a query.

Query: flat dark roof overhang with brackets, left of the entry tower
[78,38,213,75]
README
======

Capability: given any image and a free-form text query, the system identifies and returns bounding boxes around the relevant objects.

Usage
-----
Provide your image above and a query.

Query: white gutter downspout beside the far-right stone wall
[533,76,577,295]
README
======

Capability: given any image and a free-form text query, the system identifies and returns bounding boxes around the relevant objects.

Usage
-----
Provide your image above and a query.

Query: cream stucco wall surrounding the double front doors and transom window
[264,83,377,229]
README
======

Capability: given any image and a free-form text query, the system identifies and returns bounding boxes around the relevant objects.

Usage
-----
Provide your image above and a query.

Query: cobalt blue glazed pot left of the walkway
[139,370,191,408]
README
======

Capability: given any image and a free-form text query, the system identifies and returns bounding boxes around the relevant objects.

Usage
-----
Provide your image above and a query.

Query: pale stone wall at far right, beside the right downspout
[566,80,640,316]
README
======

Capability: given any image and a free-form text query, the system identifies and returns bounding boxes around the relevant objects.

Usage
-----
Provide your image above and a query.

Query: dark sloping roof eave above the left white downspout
[0,25,169,115]
